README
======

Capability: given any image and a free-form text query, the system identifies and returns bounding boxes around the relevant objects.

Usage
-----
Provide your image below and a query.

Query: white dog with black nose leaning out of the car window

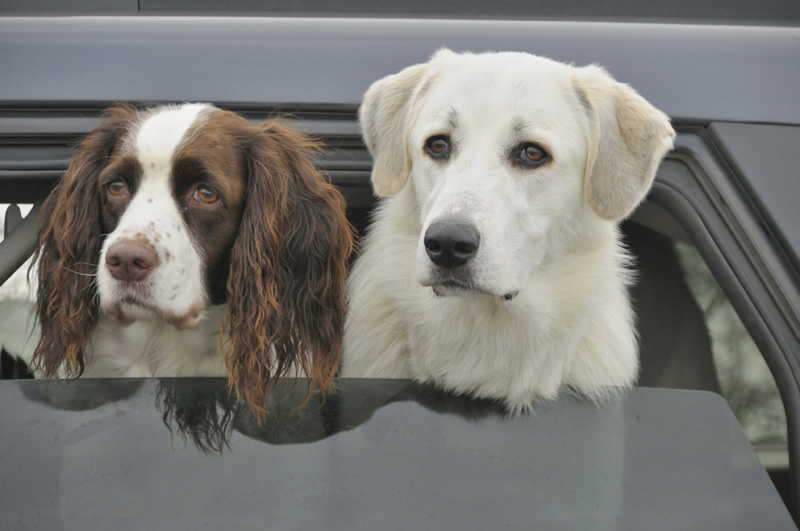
[343,50,675,411]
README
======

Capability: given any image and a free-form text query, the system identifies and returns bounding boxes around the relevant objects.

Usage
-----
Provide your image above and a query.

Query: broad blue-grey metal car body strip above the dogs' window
[0,17,800,124]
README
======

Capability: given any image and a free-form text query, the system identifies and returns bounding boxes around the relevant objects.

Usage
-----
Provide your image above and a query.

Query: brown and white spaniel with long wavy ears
[33,104,352,413]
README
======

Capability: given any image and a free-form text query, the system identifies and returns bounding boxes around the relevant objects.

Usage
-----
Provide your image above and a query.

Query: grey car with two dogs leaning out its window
[0,0,800,528]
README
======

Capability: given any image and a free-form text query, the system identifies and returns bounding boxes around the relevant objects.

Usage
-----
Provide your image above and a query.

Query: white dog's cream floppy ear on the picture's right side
[573,65,675,220]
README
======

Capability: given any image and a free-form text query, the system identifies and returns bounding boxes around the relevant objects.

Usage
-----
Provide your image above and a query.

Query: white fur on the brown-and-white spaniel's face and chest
[91,104,227,377]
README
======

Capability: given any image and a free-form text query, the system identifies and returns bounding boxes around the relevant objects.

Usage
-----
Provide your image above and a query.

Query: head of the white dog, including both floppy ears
[360,50,674,300]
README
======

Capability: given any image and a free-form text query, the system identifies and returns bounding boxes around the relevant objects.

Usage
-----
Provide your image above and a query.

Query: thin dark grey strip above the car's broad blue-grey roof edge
[7,0,800,25]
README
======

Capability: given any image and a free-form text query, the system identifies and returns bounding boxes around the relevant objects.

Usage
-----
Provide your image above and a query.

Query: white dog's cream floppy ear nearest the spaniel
[359,63,438,197]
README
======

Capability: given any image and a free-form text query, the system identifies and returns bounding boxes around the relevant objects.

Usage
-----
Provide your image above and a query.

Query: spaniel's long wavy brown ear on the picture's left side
[31,106,136,378]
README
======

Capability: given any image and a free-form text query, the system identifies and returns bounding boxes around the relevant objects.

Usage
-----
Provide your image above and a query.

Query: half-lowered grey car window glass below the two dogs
[0,379,795,530]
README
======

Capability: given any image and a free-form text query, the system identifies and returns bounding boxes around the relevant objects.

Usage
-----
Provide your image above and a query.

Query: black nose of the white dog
[423,220,481,269]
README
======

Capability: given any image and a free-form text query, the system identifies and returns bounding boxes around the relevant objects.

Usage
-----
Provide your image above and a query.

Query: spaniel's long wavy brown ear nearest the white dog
[225,121,353,418]
